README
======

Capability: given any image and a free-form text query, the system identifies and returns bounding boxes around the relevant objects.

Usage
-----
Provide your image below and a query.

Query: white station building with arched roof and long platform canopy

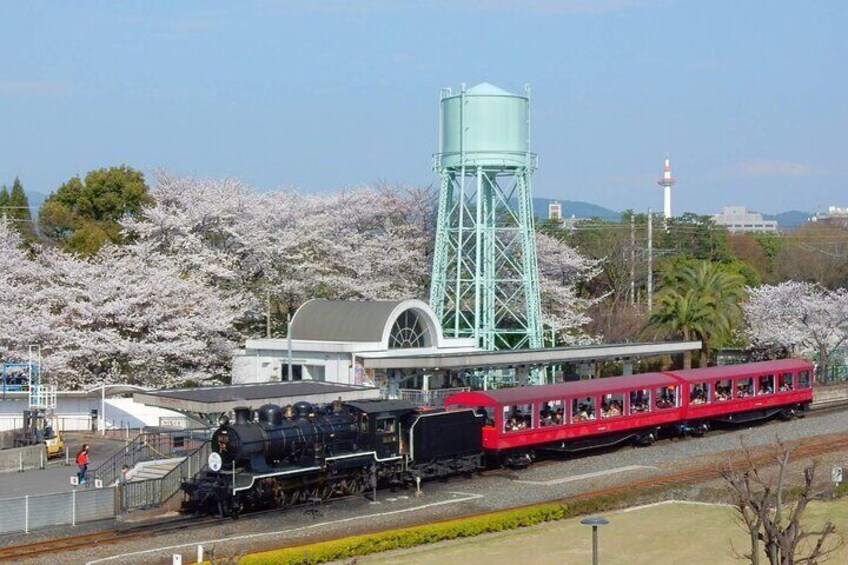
[233,299,701,404]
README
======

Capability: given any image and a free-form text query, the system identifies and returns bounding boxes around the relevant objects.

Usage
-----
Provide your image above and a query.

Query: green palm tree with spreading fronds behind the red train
[645,261,745,369]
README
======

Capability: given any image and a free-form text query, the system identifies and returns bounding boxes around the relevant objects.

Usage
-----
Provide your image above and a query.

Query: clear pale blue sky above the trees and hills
[0,0,848,214]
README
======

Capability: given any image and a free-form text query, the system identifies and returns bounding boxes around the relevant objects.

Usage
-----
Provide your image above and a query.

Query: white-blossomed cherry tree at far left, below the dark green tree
[0,218,238,389]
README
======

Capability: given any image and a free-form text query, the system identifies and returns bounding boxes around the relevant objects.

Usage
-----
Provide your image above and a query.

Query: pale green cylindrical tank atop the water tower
[436,82,534,169]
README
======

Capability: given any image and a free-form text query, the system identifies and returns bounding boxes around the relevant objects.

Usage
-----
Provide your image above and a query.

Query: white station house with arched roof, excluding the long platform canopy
[233,299,482,385]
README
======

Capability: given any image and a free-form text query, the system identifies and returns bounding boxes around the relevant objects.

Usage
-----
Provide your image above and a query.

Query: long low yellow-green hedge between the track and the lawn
[232,495,625,565]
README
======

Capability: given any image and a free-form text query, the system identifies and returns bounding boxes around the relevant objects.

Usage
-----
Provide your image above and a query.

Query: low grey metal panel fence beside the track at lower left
[0,488,117,534]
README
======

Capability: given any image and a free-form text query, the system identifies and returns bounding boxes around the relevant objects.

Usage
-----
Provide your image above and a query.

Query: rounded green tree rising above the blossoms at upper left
[38,165,153,255]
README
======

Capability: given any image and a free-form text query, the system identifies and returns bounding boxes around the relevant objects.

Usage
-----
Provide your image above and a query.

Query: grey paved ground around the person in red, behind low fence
[0,434,124,499]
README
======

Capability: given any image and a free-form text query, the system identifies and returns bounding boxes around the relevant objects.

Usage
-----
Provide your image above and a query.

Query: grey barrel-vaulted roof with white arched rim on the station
[291,299,442,347]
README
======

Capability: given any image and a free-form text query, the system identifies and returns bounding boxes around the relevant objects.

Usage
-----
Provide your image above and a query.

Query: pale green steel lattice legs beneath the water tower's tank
[430,166,542,350]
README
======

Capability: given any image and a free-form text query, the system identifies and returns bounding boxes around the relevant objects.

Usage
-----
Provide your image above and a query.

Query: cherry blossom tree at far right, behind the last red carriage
[744,281,848,378]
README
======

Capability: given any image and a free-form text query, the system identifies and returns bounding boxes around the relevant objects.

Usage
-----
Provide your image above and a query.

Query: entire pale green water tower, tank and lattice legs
[430,83,542,356]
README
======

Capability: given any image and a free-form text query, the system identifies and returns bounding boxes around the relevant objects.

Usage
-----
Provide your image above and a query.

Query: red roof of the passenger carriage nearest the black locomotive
[445,373,678,405]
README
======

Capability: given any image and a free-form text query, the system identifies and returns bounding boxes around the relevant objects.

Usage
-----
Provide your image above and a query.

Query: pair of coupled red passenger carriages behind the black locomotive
[445,359,812,465]
